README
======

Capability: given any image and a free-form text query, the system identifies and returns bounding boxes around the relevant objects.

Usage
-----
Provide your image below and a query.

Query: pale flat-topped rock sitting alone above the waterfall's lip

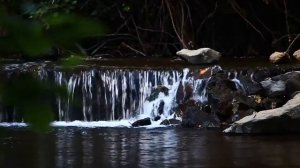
[176,48,221,64]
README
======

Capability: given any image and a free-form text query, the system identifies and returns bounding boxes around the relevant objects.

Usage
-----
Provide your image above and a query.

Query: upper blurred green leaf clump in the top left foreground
[0,1,105,57]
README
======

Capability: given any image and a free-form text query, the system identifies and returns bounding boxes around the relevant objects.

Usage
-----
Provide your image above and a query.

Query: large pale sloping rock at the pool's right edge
[223,93,300,134]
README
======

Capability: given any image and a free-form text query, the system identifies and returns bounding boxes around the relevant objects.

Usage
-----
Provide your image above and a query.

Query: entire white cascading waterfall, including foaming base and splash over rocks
[0,63,248,126]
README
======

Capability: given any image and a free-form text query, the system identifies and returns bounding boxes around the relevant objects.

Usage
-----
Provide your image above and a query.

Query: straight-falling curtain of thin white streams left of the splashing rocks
[54,69,181,121]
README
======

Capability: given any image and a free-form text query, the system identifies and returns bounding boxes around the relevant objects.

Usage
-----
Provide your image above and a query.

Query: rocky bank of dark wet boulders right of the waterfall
[135,66,300,133]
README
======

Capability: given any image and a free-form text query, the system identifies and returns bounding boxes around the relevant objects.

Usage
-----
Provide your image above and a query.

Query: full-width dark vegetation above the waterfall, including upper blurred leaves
[1,0,300,57]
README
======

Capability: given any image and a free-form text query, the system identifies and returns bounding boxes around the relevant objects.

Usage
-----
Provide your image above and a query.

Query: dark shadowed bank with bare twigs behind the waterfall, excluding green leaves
[76,0,300,57]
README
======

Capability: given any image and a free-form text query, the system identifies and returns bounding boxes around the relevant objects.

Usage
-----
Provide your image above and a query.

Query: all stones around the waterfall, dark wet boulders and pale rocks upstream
[133,48,300,133]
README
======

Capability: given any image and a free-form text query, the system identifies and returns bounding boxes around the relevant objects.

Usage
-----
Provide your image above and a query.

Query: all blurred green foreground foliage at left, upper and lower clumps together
[0,0,106,131]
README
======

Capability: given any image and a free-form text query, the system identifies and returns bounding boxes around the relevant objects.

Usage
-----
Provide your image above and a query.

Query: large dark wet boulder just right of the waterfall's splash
[207,71,262,123]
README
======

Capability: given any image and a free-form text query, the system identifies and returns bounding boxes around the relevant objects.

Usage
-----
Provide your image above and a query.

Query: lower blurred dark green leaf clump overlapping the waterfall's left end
[0,73,67,131]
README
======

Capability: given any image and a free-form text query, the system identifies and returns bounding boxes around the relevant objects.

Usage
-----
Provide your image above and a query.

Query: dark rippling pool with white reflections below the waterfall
[0,128,300,168]
